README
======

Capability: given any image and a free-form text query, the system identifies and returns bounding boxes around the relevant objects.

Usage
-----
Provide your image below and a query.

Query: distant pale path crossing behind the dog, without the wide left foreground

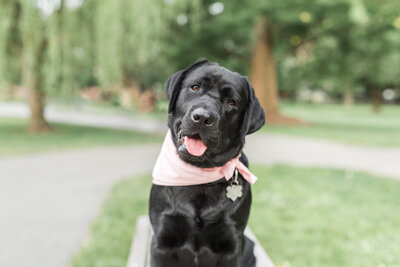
[0,102,400,179]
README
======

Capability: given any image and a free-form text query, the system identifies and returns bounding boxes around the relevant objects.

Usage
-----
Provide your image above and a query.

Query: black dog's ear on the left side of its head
[164,59,211,113]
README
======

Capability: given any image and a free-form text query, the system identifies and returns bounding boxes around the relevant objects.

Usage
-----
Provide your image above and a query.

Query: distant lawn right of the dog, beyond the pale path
[264,102,400,147]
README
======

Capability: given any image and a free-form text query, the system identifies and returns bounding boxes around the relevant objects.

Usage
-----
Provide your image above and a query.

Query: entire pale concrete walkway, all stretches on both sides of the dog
[0,101,400,267]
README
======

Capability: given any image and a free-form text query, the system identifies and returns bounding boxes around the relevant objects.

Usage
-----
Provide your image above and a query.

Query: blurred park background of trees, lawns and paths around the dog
[0,0,400,267]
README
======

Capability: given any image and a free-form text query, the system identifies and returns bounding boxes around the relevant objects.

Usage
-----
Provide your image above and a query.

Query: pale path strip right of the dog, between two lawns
[245,134,400,179]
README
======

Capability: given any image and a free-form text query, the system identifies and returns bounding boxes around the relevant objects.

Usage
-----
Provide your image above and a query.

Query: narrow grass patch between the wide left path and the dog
[71,176,151,267]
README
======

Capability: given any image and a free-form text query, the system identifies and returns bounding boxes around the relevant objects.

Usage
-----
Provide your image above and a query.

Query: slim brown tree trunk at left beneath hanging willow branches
[28,33,51,132]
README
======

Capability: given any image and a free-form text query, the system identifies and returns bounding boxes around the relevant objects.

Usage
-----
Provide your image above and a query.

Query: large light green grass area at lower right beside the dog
[250,166,400,266]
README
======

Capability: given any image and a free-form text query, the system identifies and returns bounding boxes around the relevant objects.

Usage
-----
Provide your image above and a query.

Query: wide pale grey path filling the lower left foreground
[0,145,159,267]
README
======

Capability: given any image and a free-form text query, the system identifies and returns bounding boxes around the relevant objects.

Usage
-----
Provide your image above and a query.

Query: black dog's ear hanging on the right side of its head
[241,78,265,138]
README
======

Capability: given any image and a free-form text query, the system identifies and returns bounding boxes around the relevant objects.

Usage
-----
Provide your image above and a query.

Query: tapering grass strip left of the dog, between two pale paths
[0,118,163,156]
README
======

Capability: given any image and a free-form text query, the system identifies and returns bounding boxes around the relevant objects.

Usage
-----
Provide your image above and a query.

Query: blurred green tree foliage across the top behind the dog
[0,0,400,101]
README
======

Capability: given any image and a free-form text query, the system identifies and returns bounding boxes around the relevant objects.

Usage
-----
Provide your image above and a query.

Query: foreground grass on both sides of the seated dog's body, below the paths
[71,166,400,267]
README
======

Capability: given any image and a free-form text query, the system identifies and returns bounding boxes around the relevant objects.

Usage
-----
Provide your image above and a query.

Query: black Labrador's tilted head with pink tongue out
[165,60,265,168]
